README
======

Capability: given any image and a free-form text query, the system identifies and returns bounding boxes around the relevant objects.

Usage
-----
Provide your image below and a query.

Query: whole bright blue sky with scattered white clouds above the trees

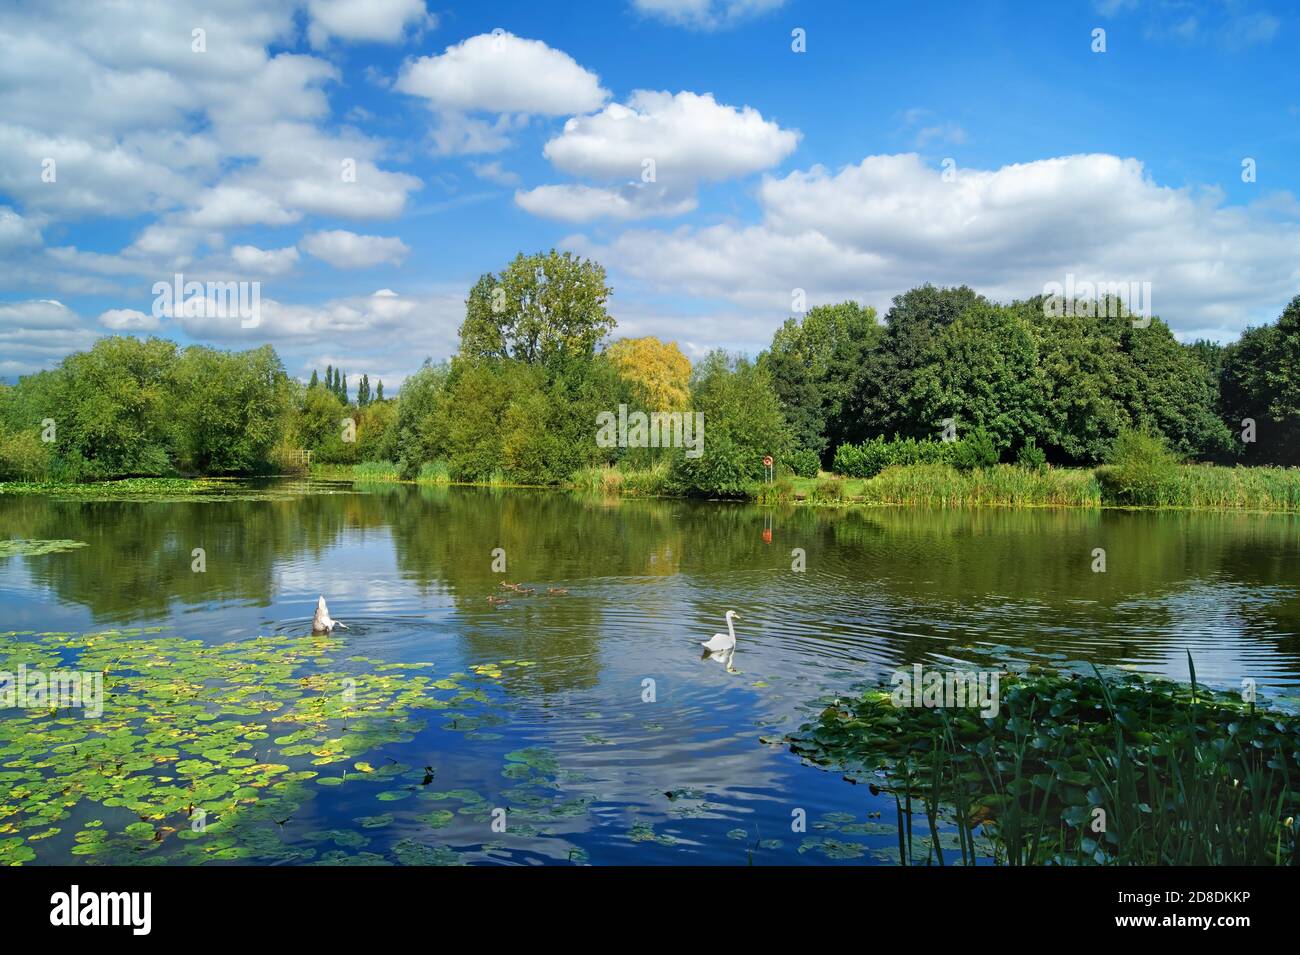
[0,0,1300,390]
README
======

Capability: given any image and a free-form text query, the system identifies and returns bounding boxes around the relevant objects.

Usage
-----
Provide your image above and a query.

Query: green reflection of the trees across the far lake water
[10,485,1300,689]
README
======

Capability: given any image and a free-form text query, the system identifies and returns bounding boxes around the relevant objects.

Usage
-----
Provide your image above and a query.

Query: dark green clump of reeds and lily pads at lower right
[787,668,1300,865]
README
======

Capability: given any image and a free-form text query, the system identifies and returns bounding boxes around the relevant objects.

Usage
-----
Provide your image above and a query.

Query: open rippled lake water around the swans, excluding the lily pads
[0,485,1300,864]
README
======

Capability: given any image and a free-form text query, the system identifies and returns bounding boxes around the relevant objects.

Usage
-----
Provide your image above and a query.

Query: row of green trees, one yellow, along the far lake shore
[0,251,1300,485]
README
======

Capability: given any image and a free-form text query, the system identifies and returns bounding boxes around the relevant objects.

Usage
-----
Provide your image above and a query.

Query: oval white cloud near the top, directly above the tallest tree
[397,31,608,116]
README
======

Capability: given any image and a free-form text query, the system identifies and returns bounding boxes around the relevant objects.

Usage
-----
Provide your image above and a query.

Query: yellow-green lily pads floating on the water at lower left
[0,628,528,864]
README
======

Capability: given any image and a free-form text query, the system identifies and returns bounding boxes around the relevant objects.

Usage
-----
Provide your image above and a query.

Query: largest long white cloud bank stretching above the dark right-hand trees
[566,153,1300,338]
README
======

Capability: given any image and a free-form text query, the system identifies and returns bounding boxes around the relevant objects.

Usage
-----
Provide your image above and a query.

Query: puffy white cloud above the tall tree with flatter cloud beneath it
[516,90,800,222]
